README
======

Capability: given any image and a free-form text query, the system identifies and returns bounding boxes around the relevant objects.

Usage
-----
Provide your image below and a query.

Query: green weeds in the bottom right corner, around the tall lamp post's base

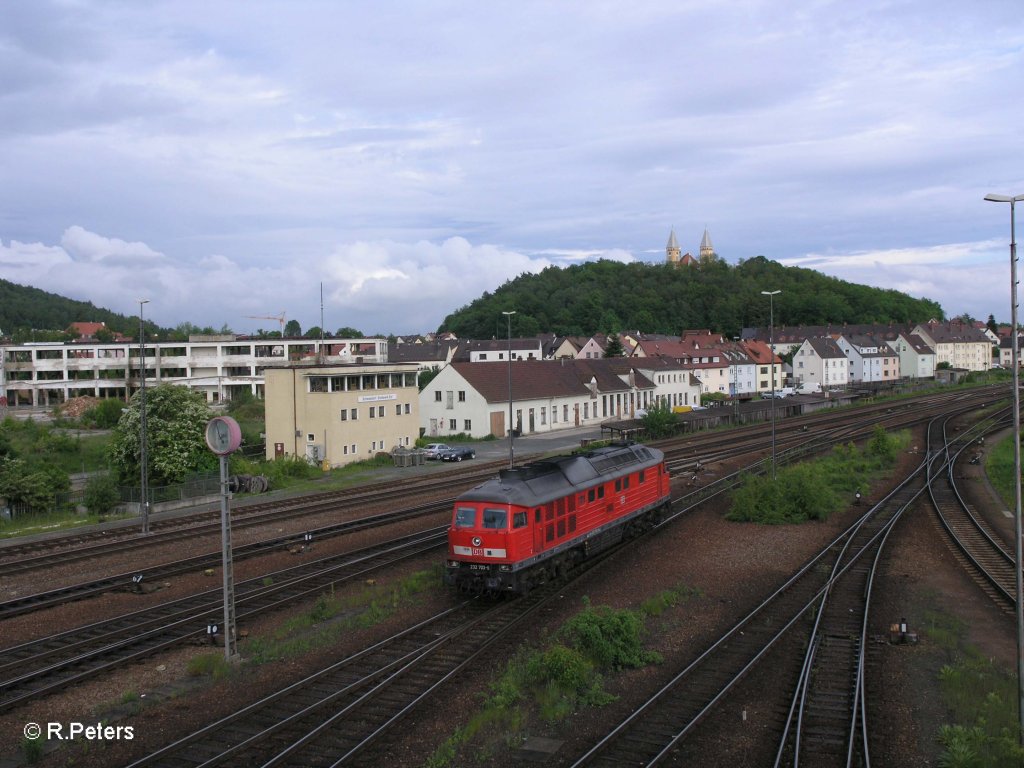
[923,611,1024,768]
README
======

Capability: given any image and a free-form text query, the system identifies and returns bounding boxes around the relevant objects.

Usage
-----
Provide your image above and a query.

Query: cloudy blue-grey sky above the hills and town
[0,0,1024,334]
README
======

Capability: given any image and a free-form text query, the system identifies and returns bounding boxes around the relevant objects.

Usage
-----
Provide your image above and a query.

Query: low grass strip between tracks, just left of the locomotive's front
[245,563,443,664]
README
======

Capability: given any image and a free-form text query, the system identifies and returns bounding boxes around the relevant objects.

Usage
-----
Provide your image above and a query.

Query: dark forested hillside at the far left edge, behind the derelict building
[0,280,167,338]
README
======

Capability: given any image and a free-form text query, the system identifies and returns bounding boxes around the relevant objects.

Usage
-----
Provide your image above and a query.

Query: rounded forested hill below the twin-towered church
[438,256,945,339]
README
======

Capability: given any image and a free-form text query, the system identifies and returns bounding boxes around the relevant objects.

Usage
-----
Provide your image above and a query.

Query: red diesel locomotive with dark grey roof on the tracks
[444,443,670,593]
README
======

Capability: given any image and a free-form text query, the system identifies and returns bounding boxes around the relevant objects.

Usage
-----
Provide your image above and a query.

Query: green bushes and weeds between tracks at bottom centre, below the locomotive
[425,587,699,768]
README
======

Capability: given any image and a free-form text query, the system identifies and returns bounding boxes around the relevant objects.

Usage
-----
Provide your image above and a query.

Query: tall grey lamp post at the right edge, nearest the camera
[985,195,1024,744]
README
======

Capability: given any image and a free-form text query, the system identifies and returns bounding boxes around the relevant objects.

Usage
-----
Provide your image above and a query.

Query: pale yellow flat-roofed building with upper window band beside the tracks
[263,362,420,467]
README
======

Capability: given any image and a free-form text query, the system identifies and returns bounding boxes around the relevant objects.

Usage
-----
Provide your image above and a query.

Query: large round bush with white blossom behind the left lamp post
[109,384,217,485]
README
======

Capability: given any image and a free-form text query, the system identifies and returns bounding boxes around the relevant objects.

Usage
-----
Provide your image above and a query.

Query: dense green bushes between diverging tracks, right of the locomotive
[726,426,910,524]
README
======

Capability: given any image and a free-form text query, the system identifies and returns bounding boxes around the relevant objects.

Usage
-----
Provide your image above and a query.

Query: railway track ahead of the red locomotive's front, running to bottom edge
[131,585,559,768]
